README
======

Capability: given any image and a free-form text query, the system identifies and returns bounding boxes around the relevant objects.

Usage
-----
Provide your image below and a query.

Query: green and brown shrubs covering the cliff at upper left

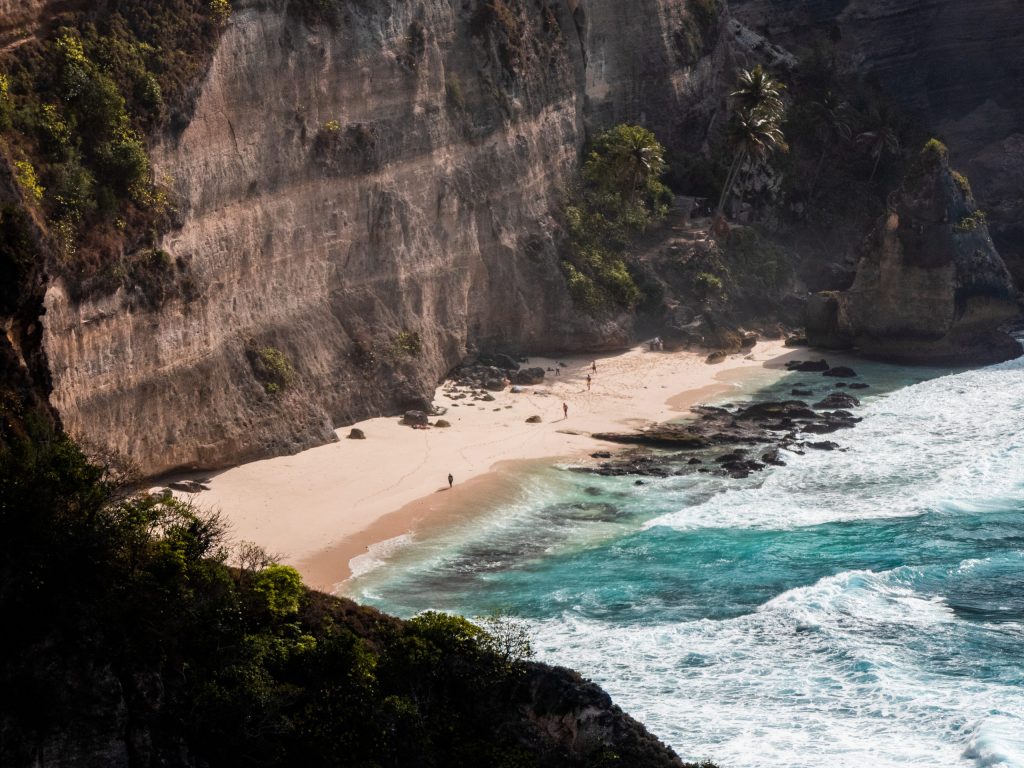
[0,0,230,300]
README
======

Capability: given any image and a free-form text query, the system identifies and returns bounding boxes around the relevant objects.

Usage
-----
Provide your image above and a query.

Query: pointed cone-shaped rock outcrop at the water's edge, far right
[807,141,1021,364]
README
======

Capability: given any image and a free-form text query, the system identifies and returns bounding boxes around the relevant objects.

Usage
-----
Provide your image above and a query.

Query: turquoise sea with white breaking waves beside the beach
[347,360,1024,768]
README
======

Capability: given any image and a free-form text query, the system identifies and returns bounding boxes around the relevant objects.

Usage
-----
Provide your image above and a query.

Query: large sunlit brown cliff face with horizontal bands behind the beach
[44,0,729,474]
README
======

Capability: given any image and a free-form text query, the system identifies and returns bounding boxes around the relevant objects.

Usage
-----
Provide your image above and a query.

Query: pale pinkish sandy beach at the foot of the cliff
[178,341,793,591]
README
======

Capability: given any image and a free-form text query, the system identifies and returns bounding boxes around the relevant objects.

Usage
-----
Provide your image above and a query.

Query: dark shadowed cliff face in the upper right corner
[729,0,1024,285]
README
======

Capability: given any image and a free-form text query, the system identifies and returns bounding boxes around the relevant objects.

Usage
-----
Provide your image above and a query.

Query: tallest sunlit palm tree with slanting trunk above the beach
[715,65,790,220]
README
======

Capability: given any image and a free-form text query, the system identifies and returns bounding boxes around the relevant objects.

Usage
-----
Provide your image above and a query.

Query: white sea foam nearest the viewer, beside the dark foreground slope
[535,568,1024,768]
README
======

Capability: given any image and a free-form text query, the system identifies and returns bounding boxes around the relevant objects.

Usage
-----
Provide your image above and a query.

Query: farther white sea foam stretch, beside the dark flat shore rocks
[647,360,1024,529]
